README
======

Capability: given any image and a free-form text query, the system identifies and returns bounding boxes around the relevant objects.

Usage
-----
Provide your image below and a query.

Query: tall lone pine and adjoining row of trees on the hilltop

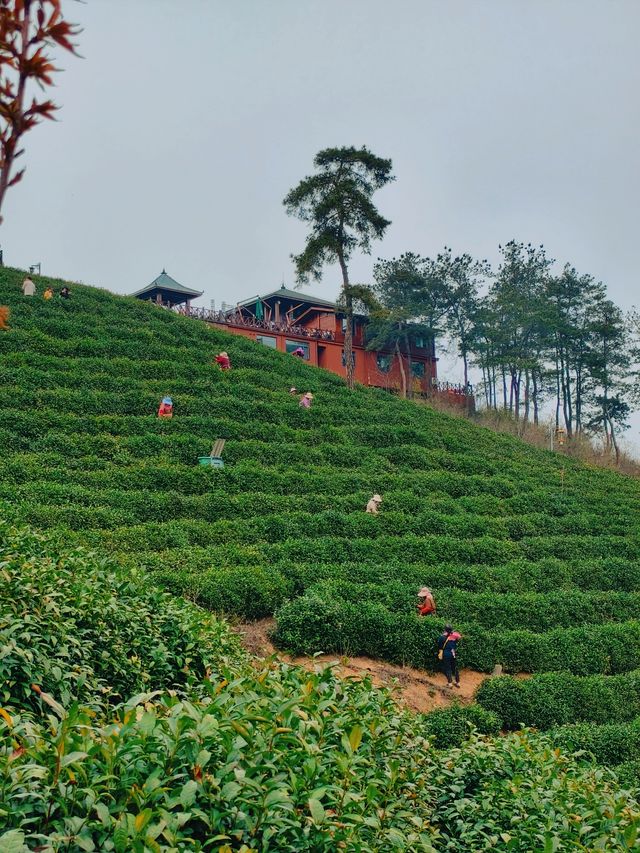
[284,147,640,457]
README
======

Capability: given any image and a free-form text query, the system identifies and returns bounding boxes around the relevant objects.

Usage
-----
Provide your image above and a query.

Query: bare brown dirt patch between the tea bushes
[234,619,489,712]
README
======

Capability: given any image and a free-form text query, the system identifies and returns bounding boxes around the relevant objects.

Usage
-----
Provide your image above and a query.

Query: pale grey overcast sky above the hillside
[0,0,640,446]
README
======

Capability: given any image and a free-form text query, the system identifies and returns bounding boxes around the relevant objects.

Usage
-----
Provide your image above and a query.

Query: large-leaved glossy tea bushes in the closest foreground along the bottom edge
[0,663,640,853]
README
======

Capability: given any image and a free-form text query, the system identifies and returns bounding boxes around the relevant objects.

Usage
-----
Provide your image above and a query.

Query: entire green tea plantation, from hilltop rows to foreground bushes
[0,269,640,853]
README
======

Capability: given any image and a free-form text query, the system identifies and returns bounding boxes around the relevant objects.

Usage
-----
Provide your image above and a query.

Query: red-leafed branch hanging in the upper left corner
[0,0,79,222]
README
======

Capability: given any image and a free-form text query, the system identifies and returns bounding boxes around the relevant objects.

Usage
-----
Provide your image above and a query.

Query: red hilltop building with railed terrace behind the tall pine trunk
[208,285,437,393]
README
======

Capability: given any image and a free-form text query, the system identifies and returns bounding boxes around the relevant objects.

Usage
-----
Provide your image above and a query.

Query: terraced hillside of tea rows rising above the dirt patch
[0,262,640,675]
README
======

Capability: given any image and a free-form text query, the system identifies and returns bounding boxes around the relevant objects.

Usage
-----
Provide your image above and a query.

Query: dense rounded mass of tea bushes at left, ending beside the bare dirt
[0,523,242,711]
